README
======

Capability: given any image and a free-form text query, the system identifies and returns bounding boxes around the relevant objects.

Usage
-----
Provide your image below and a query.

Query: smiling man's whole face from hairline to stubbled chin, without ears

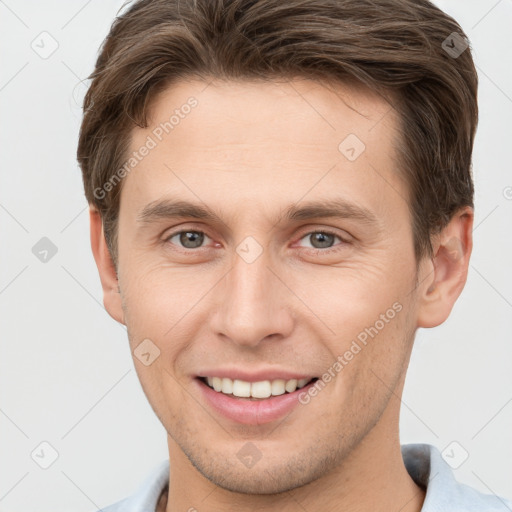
[118,80,424,494]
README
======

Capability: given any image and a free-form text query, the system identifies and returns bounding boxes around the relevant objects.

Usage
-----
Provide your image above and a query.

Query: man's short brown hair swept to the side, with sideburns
[77,0,478,266]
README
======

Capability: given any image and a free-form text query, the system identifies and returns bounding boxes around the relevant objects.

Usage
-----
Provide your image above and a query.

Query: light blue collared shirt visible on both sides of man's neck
[98,444,512,512]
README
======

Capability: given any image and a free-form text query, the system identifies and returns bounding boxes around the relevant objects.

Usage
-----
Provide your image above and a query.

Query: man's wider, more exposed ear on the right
[417,206,474,327]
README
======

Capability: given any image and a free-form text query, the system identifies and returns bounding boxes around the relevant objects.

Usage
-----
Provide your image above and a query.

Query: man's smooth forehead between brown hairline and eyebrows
[121,79,405,224]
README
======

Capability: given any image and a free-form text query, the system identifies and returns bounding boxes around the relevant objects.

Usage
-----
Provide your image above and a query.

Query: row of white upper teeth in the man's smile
[206,377,311,398]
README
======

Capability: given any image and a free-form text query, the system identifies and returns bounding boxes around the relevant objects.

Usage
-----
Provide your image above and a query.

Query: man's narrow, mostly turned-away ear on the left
[89,205,124,324]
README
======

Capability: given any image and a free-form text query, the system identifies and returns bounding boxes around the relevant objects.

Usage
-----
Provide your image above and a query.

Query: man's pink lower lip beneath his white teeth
[195,378,315,425]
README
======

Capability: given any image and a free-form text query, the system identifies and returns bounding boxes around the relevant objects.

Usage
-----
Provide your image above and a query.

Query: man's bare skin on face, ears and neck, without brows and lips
[90,79,473,512]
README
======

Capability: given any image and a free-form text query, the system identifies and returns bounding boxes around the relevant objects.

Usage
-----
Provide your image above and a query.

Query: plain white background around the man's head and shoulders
[0,0,512,512]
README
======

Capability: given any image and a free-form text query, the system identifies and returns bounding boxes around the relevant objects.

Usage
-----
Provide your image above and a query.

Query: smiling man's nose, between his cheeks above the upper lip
[212,244,296,347]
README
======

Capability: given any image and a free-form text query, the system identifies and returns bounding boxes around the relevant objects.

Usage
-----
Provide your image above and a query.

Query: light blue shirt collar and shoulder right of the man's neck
[402,444,512,512]
